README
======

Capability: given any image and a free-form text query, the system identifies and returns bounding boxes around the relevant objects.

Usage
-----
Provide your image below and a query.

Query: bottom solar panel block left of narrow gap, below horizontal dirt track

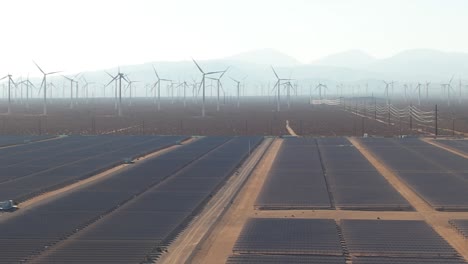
[233,218,343,256]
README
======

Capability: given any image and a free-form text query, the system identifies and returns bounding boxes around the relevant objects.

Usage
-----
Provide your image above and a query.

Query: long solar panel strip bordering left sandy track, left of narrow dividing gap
[0,138,228,263]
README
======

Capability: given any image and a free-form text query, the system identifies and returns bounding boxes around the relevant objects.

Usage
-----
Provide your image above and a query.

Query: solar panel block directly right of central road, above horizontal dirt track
[255,138,332,209]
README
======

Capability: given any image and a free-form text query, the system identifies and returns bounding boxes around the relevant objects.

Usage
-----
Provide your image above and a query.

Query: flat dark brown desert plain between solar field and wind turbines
[0,97,468,136]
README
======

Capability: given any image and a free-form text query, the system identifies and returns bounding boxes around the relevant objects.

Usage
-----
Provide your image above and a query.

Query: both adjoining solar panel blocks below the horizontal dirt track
[227,218,466,263]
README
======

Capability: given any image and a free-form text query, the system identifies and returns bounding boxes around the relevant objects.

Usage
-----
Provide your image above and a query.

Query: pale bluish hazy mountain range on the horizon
[84,49,468,82]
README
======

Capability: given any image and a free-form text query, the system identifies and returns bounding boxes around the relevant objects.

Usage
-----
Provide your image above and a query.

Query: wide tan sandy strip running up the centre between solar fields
[192,139,282,264]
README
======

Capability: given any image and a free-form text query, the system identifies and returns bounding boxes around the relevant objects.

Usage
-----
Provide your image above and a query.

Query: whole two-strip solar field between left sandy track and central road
[0,137,260,263]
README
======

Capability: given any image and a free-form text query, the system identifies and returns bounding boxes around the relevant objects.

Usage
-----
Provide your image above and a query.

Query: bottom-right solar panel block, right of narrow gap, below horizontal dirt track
[340,220,460,259]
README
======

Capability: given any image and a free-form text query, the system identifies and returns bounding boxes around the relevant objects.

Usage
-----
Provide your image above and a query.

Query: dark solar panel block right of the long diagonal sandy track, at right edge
[362,138,468,211]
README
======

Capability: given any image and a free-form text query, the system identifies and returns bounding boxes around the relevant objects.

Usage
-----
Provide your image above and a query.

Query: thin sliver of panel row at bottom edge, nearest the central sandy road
[226,254,346,264]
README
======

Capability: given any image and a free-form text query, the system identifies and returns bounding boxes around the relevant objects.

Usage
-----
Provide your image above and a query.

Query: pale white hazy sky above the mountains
[0,0,468,75]
